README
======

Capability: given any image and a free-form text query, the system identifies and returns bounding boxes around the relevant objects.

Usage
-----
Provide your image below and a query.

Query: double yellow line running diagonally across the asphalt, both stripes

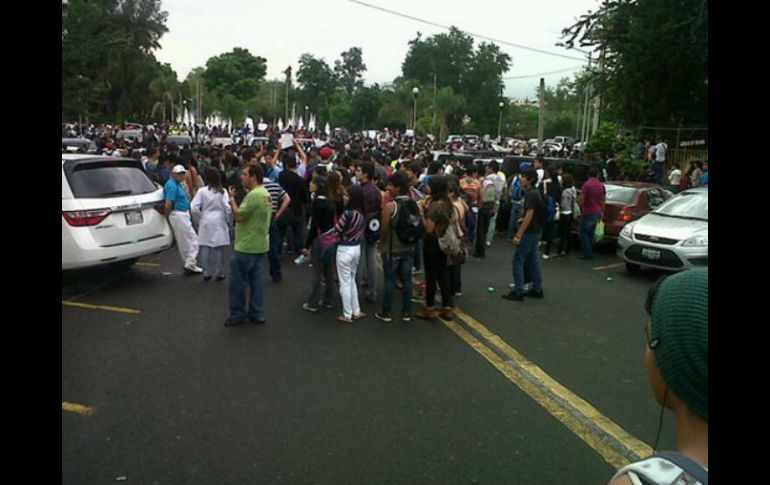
[441,309,653,468]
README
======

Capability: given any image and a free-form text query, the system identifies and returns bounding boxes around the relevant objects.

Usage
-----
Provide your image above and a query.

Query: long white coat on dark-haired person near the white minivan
[190,186,232,247]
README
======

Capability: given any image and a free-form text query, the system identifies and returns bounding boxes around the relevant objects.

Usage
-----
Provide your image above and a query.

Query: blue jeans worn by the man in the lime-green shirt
[229,251,265,320]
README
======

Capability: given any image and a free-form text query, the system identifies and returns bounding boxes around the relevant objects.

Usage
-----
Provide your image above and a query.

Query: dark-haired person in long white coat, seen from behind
[190,168,232,281]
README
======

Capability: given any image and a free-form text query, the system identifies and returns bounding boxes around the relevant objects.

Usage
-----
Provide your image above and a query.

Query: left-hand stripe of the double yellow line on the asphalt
[441,320,630,468]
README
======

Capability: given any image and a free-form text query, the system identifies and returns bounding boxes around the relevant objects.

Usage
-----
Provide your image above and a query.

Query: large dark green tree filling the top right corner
[562,0,708,126]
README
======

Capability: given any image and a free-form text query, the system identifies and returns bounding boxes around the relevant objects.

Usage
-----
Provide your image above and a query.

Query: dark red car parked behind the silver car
[572,181,674,241]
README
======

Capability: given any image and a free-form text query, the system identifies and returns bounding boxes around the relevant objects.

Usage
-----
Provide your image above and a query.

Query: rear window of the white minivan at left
[64,160,157,199]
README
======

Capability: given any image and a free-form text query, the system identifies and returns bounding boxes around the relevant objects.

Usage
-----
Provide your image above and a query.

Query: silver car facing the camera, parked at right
[618,188,709,272]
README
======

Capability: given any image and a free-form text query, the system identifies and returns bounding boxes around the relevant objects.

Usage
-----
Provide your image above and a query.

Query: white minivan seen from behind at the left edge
[61,154,174,270]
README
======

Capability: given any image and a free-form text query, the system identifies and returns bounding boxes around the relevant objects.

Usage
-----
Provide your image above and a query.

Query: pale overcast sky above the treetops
[155,0,600,100]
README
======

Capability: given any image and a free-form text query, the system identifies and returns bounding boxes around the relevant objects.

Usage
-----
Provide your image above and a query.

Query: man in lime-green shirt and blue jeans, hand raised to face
[225,164,272,327]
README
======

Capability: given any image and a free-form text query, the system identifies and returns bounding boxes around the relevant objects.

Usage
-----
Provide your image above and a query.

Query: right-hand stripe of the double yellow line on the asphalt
[455,308,653,458]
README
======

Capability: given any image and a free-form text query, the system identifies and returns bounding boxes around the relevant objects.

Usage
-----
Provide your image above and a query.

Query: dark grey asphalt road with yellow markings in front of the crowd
[62,239,674,484]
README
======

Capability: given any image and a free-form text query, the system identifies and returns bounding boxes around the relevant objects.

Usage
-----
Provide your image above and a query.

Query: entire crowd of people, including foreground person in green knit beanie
[63,120,708,485]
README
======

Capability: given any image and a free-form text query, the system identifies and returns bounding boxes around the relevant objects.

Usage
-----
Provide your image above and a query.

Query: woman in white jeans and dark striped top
[335,185,366,323]
